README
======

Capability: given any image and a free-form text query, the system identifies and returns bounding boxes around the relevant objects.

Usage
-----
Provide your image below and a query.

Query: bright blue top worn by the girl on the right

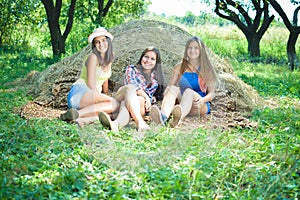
[179,72,206,97]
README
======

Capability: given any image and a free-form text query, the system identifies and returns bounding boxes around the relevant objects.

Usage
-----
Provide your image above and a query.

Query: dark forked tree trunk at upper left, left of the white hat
[41,0,76,57]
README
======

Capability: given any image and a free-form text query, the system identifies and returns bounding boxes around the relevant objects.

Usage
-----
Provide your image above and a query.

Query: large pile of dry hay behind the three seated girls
[19,20,260,126]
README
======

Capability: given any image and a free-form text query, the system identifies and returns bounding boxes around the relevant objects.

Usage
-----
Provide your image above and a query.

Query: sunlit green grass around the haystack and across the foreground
[0,23,300,199]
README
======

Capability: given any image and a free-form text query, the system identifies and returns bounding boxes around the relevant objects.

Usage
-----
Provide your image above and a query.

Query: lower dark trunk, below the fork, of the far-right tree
[286,31,299,71]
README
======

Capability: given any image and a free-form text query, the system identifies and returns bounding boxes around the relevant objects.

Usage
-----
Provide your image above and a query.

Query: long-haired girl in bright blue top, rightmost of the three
[150,36,218,127]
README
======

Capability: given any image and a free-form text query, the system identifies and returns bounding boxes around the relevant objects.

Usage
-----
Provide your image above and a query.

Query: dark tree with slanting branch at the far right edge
[269,0,300,71]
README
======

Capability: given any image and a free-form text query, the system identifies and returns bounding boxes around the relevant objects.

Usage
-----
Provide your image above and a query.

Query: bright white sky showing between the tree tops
[149,0,295,19]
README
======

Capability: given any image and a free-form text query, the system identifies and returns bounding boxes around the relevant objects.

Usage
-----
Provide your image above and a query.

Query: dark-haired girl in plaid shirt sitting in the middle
[98,47,164,131]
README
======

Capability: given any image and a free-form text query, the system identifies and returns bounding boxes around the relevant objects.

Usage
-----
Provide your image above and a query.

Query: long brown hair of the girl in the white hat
[92,37,114,66]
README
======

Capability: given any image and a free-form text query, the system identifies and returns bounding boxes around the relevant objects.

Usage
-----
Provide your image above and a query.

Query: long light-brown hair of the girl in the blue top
[180,36,218,90]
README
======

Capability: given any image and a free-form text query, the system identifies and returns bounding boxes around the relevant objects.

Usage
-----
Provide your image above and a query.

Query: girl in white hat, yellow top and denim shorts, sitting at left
[60,27,119,125]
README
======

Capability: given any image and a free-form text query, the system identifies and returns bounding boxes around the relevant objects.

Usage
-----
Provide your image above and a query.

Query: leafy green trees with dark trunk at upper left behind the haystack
[0,0,149,58]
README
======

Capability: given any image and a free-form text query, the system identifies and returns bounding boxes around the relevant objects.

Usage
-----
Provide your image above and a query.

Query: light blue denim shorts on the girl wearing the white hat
[67,84,89,110]
